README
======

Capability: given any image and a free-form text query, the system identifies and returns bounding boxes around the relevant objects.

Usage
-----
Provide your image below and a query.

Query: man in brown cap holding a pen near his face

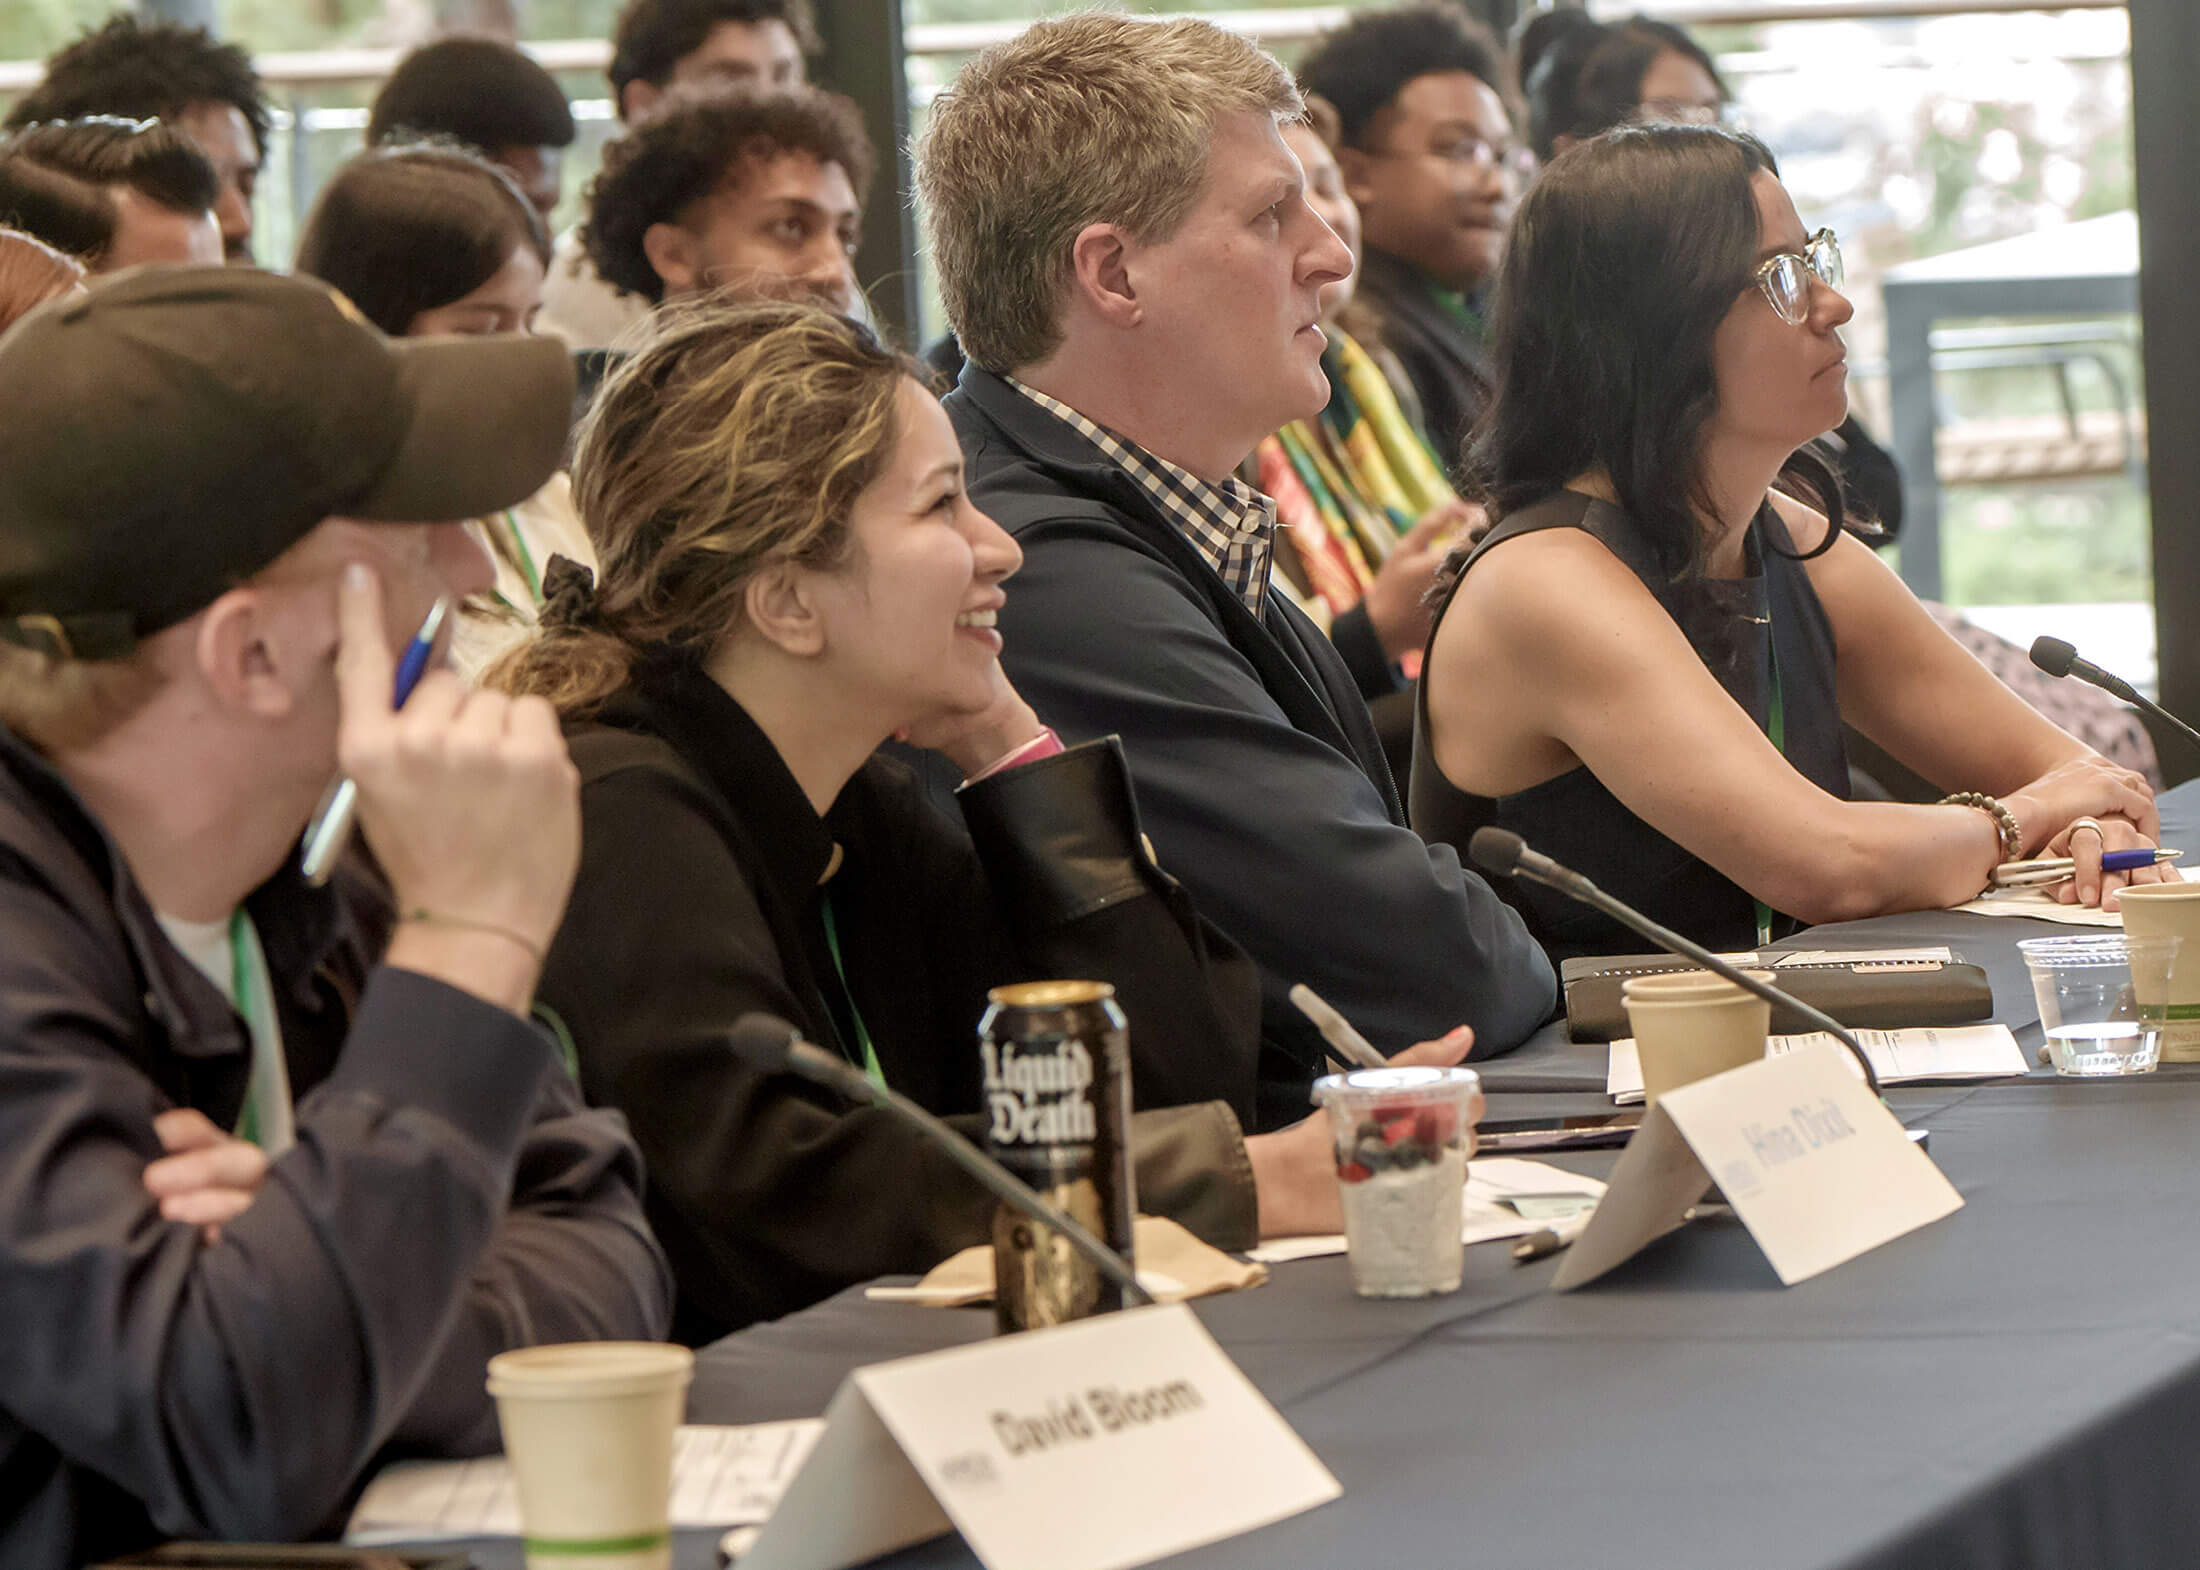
[0,268,669,1568]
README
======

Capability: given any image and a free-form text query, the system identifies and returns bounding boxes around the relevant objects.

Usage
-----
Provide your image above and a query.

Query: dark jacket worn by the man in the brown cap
[0,734,671,1570]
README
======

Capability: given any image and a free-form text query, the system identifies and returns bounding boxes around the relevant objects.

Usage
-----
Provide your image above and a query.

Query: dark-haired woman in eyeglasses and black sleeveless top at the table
[1412,125,2156,957]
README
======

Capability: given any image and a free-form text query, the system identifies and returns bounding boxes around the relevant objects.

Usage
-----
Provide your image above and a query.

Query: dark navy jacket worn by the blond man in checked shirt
[946,365,1558,1128]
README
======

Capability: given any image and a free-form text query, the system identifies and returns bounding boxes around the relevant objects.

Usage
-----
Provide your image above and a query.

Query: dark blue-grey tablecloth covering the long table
[693,1077,2200,1570]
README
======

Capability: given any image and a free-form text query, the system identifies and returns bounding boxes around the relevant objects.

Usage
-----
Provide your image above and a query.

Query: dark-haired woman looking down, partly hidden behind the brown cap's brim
[297,143,596,675]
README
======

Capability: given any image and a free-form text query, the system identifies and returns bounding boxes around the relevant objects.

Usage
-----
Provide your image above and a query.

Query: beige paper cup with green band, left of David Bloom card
[488,1341,695,1570]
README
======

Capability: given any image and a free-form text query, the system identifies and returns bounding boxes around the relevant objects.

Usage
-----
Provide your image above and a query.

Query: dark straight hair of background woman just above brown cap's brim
[295,143,550,336]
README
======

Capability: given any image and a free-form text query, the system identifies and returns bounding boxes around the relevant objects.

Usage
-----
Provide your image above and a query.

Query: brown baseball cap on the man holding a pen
[0,266,572,660]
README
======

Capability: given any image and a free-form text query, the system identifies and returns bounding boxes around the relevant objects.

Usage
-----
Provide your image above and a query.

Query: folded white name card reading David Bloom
[739,1304,1340,1570]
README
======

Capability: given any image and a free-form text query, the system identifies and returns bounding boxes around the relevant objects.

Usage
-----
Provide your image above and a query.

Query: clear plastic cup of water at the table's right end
[2017,935,2178,1077]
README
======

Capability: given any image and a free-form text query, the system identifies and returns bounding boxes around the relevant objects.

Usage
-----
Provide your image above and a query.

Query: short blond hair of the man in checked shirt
[917,11,1302,372]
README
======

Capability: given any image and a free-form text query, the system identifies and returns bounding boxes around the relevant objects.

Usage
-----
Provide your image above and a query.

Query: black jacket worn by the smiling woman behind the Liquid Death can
[543,657,1258,1341]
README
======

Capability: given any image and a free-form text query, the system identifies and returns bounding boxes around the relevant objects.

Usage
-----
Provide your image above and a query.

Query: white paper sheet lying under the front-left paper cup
[343,1418,825,1544]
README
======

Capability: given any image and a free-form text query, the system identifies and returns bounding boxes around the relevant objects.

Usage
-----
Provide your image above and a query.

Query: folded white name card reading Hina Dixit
[1551,1042,1962,1291]
